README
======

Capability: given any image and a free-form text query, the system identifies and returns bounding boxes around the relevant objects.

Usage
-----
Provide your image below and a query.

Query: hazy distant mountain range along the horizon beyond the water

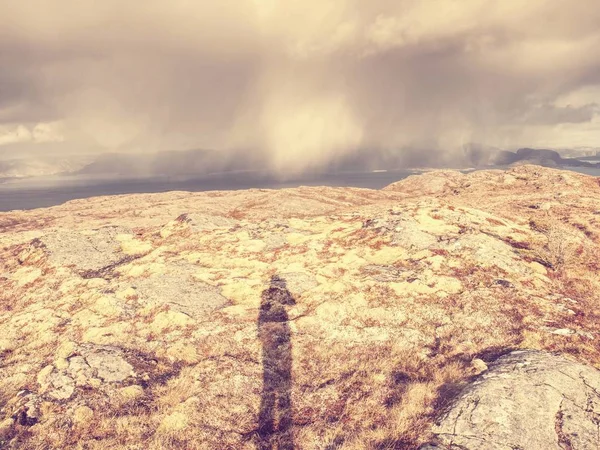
[0,144,600,180]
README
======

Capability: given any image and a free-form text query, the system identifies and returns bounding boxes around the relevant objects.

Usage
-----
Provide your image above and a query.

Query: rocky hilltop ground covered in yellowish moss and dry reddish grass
[0,166,600,450]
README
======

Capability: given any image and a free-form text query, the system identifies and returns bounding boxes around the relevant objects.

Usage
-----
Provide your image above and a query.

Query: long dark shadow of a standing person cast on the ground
[258,275,296,450]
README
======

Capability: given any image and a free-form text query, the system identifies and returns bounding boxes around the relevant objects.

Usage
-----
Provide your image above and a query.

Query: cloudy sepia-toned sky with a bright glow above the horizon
[0,0,600,171]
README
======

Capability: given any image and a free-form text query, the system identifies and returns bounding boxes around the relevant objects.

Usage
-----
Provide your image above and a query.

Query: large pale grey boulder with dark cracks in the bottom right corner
[432,351,600,450]
